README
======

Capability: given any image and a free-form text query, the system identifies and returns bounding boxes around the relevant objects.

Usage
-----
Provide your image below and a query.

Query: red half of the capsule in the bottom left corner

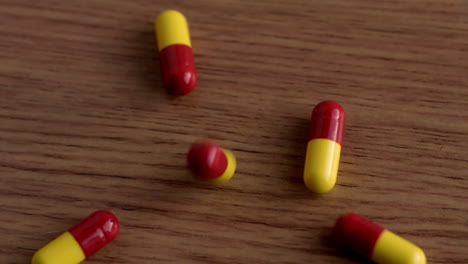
[68,210,119,258]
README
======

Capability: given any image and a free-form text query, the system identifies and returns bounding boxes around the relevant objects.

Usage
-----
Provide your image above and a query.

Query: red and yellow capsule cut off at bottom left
[32,210,119,264]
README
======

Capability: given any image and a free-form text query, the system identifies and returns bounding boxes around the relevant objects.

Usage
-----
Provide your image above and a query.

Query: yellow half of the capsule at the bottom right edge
[372,230,426,264]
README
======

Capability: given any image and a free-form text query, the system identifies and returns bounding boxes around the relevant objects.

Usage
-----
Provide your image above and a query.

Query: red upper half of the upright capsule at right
[308,101,345,145]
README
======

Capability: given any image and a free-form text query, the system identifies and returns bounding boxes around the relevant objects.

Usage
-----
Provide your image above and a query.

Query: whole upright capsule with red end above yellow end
[304,101,345,193]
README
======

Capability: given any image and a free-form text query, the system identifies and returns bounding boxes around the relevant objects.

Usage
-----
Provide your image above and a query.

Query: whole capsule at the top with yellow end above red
[155,10,197,96]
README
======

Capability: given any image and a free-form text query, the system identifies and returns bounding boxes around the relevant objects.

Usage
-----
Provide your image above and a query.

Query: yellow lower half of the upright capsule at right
[304,138,341,193]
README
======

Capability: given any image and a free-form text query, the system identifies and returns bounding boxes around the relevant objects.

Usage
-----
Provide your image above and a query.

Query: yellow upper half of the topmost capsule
[154,10,192,51]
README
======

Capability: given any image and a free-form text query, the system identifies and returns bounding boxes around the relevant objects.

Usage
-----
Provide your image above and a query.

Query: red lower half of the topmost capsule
[159,44,197,96]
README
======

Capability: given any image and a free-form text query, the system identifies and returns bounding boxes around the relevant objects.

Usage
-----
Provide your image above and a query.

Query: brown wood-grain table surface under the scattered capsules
[0,0,468,264]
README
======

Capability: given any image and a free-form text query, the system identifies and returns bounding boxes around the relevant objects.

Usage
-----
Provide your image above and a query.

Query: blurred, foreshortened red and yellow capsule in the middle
[187,140,236,182]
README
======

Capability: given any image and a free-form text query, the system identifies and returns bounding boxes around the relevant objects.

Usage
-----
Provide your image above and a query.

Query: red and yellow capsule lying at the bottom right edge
[333,213,426,264]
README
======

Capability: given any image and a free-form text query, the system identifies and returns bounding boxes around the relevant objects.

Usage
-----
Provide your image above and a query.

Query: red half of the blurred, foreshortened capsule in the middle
[187,141,228,179]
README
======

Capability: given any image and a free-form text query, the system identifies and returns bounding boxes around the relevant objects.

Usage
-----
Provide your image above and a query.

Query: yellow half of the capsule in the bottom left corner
[31,232,86,264]
